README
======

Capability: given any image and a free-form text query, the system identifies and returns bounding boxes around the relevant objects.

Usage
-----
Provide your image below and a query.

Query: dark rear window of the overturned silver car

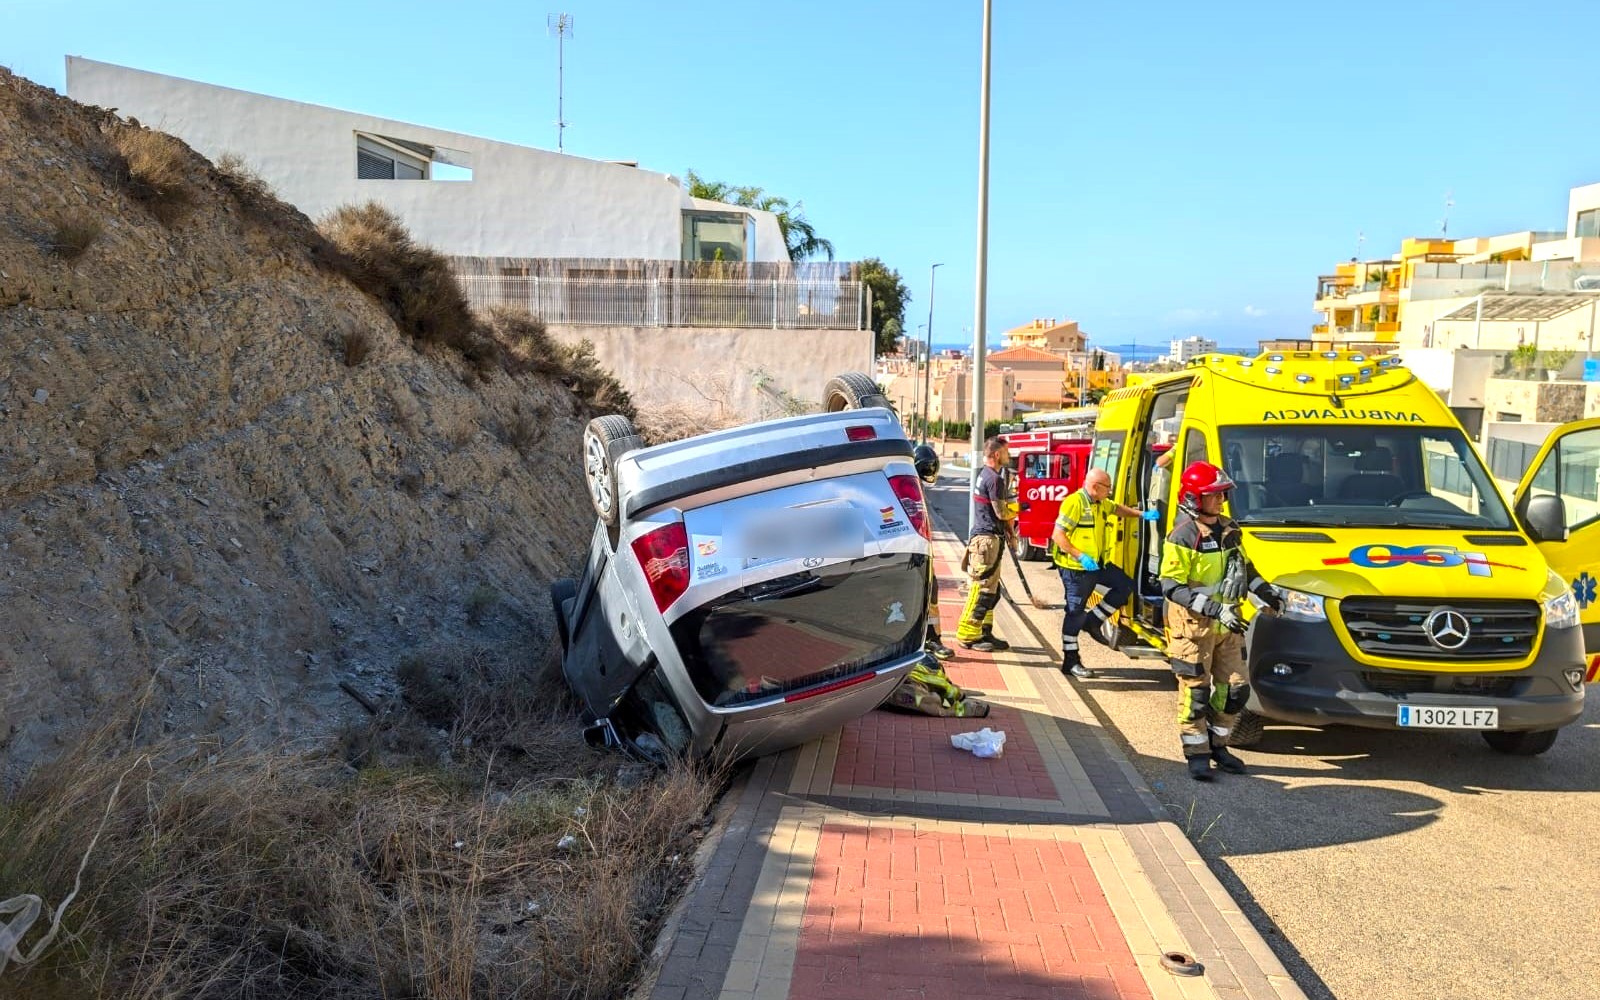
[672,552,928,707]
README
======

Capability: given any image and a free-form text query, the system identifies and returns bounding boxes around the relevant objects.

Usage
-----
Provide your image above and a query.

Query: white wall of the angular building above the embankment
[67,56,789,261]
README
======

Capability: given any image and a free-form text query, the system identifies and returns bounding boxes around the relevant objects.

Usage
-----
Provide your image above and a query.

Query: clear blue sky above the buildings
[0,0,1600,344]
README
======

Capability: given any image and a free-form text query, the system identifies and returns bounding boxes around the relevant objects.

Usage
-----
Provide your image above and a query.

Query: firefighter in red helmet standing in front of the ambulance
[1162,462,1282,781]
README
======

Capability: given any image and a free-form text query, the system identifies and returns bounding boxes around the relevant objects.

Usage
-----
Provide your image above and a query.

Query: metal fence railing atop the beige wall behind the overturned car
[456,272,870,330]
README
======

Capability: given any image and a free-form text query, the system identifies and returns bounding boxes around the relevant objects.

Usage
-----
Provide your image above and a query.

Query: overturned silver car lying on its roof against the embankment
[552,376,931,760]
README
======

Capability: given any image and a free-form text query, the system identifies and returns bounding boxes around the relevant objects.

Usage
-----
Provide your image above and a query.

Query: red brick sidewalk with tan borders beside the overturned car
[650,502,1304,1000]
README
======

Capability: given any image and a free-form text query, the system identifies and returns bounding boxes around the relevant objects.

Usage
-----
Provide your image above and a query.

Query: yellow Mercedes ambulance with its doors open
[1090,350,1600,755]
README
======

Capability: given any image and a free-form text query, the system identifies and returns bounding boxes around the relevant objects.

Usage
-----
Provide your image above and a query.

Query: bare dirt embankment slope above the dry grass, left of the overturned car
[0,70,594,786]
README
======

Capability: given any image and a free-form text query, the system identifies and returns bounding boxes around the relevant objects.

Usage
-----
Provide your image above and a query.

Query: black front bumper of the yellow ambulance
[1246,616,1584,731]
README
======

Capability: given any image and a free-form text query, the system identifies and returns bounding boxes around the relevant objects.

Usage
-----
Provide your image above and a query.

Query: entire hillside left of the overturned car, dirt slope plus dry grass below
[0,70,715,1000]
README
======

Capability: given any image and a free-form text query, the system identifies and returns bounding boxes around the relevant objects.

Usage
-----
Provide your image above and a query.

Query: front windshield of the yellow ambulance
[1221,424,1514,531]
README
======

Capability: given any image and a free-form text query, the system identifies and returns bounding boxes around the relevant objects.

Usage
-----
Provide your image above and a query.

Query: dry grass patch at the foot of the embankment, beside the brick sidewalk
[0,643,722,1000]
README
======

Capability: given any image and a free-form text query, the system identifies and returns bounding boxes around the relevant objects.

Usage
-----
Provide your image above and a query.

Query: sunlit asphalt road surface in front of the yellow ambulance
[930,478,1600,1000]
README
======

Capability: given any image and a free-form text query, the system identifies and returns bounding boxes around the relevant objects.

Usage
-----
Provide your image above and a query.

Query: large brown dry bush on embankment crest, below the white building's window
[317,202,483,371]
